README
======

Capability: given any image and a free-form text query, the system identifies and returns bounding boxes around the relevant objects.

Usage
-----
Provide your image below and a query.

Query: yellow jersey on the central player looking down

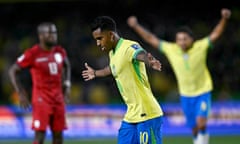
[109,38,163,123]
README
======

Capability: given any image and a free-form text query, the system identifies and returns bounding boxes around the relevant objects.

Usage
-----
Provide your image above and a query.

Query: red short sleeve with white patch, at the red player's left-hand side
[16,50,34,68]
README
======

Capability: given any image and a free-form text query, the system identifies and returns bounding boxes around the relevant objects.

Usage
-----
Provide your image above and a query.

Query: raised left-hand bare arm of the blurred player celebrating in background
[127,16,160,49]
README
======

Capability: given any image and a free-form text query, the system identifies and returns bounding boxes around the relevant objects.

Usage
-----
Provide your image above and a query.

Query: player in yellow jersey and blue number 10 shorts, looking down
[82,16,163,144]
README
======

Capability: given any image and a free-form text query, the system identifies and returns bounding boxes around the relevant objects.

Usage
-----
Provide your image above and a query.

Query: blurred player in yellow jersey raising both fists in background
[127,8,231,144]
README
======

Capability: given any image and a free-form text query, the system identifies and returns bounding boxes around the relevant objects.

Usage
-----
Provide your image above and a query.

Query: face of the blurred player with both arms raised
[176,32,193,51]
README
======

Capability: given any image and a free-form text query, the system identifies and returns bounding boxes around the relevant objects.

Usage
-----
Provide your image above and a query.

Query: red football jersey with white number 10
[17,44,66,104]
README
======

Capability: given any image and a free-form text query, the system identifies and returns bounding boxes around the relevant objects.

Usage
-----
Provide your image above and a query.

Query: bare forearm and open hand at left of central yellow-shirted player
[82,63,112,81]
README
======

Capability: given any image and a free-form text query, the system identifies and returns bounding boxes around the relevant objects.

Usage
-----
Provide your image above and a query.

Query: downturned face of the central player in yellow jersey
[92,28,113,52]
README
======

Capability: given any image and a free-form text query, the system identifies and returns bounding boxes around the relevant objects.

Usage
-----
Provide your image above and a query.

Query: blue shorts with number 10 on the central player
[118,117,163,144]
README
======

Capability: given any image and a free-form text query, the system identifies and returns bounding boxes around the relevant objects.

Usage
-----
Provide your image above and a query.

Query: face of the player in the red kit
[40,25,57,47]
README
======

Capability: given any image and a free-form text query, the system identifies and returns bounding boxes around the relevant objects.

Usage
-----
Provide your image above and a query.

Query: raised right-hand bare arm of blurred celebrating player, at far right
[209,8,231,42]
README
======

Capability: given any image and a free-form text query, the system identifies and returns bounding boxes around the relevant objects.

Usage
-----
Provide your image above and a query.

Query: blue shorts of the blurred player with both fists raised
[180,92,211,128]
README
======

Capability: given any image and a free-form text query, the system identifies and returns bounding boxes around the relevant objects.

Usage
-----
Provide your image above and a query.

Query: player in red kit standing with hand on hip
[9,23,71,144]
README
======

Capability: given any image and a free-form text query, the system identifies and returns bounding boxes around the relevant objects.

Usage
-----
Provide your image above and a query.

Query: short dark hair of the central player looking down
[91,16,116,32]
